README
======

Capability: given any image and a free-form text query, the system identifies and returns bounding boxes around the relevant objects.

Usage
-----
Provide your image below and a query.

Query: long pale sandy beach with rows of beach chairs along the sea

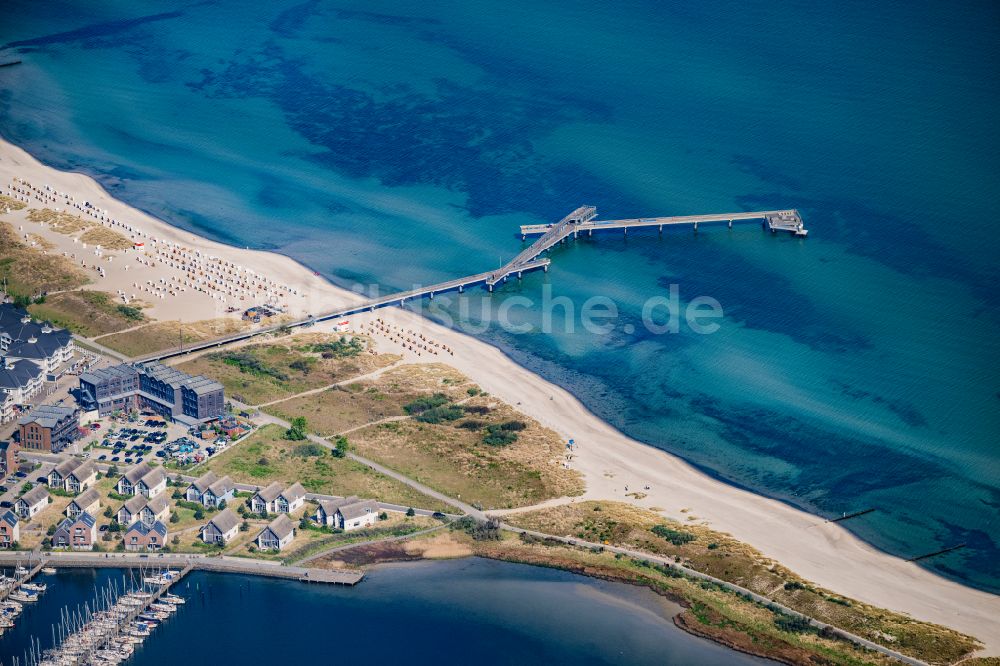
[0,137,1000,655]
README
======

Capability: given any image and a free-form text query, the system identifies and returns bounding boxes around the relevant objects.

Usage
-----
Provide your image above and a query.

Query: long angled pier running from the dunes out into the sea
[133,206,809,363]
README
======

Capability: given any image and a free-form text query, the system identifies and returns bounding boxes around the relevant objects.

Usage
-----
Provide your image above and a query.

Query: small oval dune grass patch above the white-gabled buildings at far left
[28,290,145,338]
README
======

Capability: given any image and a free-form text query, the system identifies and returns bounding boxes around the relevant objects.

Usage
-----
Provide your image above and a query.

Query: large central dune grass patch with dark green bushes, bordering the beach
[332,365,583,508]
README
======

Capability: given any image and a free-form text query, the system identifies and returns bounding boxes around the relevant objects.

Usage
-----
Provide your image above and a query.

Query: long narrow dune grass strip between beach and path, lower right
[506,502,976,664]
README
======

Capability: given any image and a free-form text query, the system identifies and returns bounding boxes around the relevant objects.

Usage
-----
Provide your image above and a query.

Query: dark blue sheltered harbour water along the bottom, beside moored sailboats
[0,558,770,666]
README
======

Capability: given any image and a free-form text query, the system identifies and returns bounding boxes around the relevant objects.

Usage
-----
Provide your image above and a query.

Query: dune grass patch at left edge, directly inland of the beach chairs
[0,222,90,296]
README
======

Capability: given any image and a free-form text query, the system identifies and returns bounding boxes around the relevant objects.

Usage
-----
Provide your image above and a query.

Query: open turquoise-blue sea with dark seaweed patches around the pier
[0,0,1000,591]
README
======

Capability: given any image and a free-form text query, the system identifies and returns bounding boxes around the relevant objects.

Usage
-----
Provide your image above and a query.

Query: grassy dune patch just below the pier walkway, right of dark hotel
[178,333,399,405]
